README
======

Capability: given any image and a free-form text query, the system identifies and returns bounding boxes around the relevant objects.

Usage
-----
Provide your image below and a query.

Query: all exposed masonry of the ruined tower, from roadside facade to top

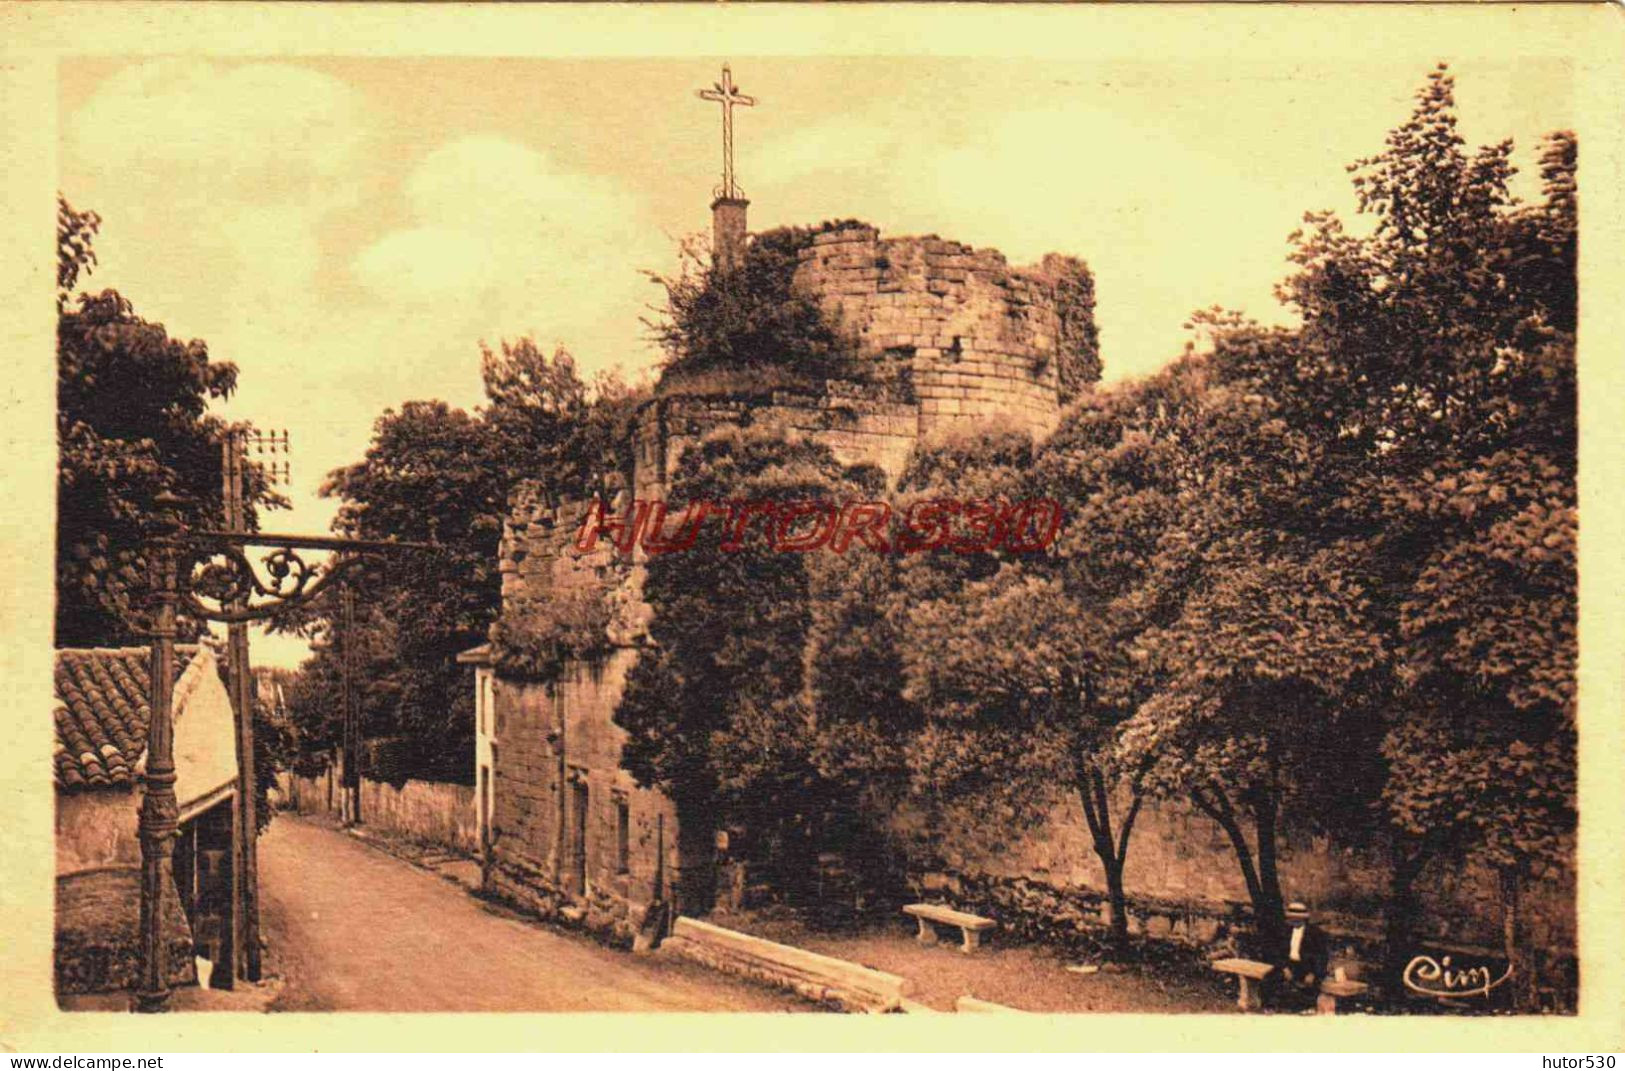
[486,195,1099,941]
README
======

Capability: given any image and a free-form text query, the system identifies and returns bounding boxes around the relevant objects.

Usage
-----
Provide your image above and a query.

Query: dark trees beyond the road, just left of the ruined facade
[279,338,634,777]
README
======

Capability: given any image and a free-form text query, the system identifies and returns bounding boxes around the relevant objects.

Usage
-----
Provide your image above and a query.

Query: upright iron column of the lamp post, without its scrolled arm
[135,491,180,1012]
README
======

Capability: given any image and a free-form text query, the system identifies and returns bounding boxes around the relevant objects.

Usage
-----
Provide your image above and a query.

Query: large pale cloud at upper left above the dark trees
[63,59,375,342]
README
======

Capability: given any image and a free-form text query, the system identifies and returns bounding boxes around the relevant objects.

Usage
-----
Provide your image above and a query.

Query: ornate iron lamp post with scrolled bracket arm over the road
[135,491,436,1012]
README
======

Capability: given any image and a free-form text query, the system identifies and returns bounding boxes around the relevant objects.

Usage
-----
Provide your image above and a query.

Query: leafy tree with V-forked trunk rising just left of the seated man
[1120,533,1381,949]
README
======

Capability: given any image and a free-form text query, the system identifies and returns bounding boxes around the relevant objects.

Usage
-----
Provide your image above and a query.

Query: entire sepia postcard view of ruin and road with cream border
[0,3,1625,1066]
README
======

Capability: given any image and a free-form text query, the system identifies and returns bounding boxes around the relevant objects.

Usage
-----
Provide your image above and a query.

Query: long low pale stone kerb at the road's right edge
[660,917,908,1011]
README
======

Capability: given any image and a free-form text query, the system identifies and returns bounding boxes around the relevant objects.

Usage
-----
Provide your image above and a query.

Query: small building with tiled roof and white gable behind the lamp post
[50,645,237,993]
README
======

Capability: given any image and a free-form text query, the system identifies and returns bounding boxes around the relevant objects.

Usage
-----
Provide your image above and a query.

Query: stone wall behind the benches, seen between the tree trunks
[892,801,1578,1006]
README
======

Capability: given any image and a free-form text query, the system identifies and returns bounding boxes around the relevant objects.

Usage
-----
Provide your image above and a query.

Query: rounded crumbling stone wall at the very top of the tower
[793,226,1061,432]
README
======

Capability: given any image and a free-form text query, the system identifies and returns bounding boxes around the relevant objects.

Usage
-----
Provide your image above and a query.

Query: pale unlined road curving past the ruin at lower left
[260,814,808,1011]
